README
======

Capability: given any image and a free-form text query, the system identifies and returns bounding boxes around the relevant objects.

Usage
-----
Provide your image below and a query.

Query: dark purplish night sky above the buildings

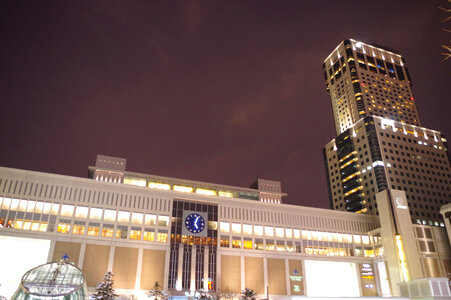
[0,0,451,208]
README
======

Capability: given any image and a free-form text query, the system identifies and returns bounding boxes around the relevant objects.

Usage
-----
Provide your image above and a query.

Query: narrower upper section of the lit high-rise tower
[323,39,421,135]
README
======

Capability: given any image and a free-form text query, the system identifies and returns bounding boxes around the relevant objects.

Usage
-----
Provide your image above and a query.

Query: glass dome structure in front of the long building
[11,261,88,300]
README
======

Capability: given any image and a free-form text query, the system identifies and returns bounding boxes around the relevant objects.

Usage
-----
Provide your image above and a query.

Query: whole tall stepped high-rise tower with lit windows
[323,40,451,226]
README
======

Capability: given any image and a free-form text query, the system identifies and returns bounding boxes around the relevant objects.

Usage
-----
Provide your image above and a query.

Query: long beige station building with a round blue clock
[0,156,451,299]
